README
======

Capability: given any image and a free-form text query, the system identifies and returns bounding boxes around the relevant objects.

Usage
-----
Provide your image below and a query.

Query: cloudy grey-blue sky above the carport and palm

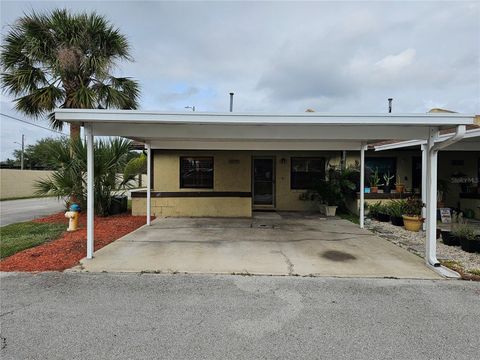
[1,0,480,160]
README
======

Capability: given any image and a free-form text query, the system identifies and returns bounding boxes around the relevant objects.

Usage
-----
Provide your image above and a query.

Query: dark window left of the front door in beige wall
[180,157,213,189]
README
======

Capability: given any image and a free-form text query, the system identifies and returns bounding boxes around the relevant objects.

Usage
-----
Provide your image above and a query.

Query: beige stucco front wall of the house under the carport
[132,150,340,217]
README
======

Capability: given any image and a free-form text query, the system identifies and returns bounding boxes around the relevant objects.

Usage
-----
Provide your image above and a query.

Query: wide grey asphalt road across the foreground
[0,273,480,360]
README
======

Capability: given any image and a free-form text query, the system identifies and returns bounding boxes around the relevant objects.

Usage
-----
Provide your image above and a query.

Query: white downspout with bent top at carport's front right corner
[425,125,466,267]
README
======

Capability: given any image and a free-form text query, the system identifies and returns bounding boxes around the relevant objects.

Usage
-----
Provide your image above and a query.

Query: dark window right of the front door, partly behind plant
[290,157,325,190]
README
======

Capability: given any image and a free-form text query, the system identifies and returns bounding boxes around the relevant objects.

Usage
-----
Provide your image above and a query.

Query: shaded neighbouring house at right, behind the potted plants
[364,114,480,219]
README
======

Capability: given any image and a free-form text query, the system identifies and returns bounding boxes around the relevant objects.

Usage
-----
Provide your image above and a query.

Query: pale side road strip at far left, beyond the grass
[0,197,65,226]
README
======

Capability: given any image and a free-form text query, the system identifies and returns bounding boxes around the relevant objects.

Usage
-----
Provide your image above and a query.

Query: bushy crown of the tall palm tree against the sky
[0,10,139,138]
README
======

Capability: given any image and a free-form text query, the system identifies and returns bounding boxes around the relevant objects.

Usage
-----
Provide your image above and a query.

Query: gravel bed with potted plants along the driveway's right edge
[365,219,480,271]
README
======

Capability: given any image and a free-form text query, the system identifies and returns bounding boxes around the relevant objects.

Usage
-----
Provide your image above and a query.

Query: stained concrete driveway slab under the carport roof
[77,213,440,279]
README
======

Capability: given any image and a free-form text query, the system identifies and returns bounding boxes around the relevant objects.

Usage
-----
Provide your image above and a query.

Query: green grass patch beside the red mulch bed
[0,222,66,259]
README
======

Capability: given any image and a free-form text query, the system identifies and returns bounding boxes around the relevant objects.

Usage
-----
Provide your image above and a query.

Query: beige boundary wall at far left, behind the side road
[0,169,52,199]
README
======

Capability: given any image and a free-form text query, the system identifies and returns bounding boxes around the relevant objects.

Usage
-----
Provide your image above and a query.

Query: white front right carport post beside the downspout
[425,128,440,266]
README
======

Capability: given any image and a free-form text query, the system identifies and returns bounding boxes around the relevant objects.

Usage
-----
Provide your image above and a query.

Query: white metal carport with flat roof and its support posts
[55,109,474,272]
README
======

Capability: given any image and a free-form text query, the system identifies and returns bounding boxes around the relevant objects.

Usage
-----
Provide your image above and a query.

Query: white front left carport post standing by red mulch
[84,124,94,259]
